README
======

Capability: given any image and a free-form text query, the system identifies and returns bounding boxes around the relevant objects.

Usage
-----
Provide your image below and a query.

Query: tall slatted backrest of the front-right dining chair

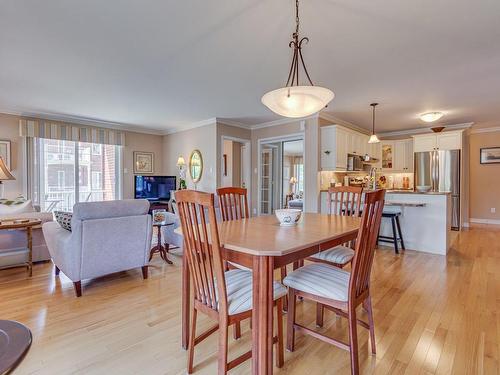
[349,190,385,301]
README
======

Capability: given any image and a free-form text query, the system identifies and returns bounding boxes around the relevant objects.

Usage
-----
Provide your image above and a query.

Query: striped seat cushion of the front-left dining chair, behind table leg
[225,269,287,315]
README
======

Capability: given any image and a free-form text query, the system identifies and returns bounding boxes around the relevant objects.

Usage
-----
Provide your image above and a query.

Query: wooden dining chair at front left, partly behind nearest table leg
[176,190,286,374]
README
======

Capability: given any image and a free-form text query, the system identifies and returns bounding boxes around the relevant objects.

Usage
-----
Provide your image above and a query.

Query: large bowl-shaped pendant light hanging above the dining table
[262,0,335,118]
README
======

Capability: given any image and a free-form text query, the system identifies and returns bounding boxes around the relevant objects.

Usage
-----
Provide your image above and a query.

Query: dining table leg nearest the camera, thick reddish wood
[252,256,274,375]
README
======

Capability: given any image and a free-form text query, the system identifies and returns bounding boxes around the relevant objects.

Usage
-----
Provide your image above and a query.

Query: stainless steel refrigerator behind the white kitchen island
[415,150,460,230]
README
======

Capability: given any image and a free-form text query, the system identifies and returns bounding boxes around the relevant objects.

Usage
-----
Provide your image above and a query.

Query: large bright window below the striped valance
[29,138,122,211]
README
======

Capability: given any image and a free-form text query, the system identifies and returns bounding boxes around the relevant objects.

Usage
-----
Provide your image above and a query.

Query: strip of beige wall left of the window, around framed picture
[0,113,25,198]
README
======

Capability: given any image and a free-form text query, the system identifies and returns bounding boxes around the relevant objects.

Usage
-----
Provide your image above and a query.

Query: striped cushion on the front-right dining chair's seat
[283,263,351,302]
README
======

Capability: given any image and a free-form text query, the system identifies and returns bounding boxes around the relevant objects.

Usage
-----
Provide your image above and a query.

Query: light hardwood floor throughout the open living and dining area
[0,226,500,375]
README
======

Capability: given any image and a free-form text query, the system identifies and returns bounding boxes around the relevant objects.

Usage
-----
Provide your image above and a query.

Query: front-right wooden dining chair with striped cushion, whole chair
[283,190,385,374]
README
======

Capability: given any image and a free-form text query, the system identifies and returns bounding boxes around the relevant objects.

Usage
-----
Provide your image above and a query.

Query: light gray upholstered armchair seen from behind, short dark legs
[42,200,152,297]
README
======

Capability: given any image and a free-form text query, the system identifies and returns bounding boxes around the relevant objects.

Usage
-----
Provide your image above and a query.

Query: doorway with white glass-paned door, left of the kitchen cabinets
[258,136,304,215]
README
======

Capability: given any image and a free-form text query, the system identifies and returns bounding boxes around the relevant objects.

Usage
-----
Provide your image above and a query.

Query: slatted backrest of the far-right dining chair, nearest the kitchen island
[328,186,363,216]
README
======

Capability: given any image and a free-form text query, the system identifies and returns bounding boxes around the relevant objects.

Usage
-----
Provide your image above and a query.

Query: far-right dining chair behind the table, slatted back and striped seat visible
[307,186,363,268]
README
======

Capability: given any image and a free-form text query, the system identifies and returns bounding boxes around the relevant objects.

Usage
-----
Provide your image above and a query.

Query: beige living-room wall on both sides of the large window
[0,114,163,198]
